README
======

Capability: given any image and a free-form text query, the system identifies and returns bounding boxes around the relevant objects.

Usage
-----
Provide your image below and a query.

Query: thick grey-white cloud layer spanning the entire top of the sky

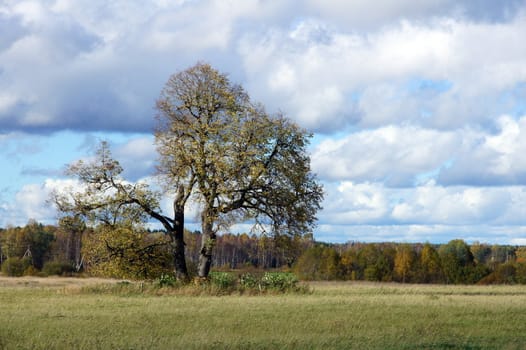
[0,0,526,132]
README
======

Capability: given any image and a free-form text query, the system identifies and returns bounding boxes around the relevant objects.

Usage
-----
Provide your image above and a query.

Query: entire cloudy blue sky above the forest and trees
[0,0,526,244]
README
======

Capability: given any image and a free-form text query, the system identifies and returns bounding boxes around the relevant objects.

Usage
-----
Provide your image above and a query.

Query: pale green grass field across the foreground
[0,277,526,350]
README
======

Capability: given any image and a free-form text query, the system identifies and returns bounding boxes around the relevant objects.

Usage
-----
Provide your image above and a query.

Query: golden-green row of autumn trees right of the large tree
[294,239,526,284]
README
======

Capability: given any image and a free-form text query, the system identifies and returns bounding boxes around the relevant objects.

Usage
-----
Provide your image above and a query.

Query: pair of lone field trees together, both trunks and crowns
[55,64,323,278]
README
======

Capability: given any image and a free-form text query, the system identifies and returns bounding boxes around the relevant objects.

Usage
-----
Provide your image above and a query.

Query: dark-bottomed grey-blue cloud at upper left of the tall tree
[0,0,290,132]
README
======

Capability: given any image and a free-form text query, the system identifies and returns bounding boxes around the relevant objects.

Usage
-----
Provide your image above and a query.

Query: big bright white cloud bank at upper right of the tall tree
[239,14,526,132]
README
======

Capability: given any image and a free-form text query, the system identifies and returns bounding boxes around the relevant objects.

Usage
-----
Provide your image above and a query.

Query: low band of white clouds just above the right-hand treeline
[315,182,526,244]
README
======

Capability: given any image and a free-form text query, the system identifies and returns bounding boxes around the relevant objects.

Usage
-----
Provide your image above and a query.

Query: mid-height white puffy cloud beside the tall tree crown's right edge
[311,125,461,186]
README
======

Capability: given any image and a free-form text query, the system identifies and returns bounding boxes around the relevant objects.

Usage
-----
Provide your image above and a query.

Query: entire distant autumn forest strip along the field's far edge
[0,219,526,284]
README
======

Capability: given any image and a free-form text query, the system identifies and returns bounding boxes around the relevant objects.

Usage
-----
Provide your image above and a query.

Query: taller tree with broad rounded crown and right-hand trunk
[155,64,323,277]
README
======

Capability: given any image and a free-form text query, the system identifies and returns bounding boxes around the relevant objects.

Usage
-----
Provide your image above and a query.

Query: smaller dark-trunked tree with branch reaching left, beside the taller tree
[52,142,190,280]
